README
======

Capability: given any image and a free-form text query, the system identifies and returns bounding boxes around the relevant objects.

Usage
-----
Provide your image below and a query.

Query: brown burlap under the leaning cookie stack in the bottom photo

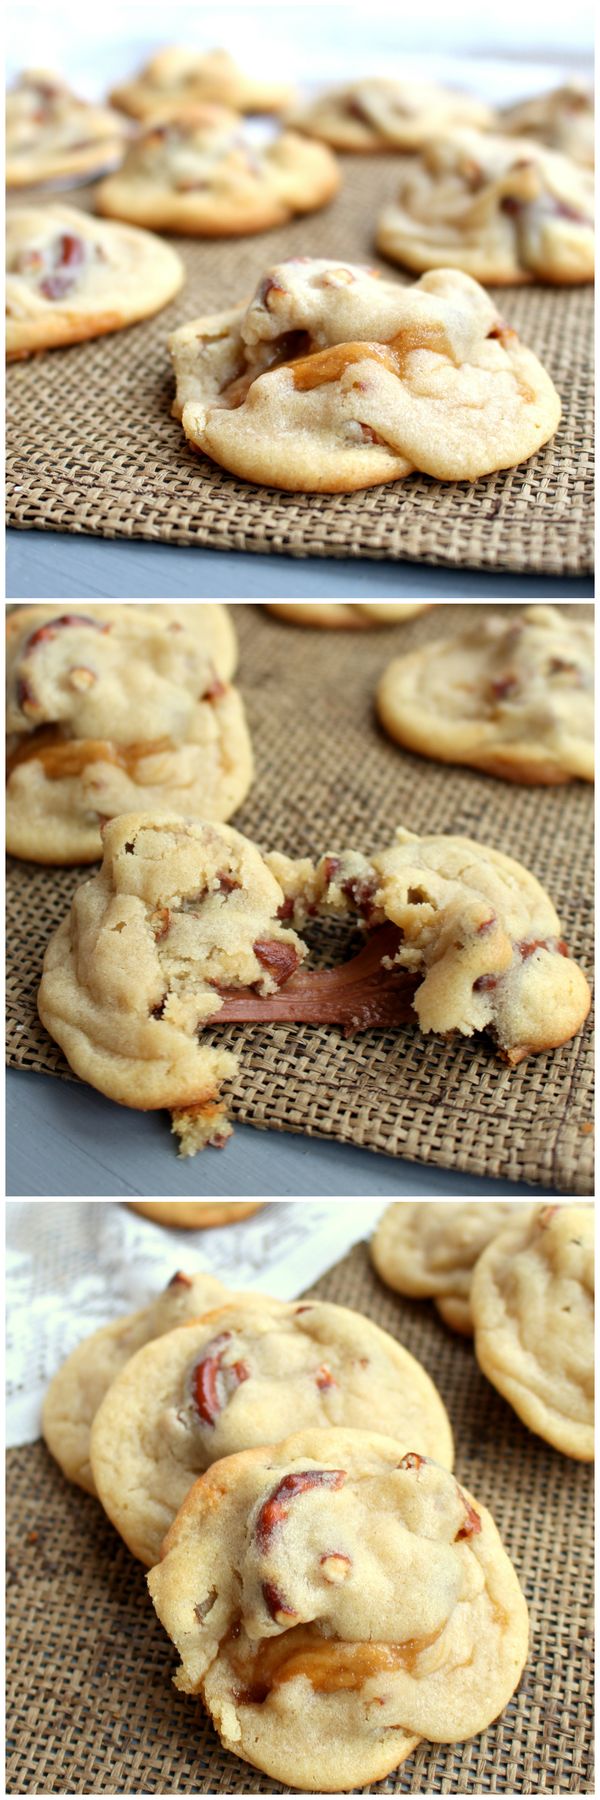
[7,1238,593,1795]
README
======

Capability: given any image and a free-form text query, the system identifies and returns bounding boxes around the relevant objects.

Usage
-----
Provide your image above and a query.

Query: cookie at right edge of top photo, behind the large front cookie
[377,131,595,286]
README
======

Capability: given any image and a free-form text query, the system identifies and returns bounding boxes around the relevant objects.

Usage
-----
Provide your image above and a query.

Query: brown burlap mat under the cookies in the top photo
[7,157,593,574]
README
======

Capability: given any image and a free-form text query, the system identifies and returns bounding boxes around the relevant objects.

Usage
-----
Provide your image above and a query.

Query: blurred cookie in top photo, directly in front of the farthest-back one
[97,104,341,238]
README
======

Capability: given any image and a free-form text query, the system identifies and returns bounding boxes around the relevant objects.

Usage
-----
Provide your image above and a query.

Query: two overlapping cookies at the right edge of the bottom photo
[371,1201,595,1462]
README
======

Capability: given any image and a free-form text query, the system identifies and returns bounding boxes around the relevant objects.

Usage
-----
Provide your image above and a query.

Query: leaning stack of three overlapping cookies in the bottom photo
[43,1273,528,1791]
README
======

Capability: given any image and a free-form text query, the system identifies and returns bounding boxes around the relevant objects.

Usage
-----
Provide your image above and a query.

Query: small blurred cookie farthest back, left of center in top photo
[110,49,294,119]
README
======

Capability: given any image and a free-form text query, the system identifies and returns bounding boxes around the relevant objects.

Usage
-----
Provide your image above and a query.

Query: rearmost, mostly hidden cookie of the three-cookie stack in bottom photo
[41,1273,231,1494]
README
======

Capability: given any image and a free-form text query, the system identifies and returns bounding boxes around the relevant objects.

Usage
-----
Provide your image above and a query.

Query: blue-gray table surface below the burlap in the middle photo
[5,1069,551,1199]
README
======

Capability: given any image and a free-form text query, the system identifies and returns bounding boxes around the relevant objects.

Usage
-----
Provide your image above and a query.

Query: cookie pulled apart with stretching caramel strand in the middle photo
[38,814,589,1156]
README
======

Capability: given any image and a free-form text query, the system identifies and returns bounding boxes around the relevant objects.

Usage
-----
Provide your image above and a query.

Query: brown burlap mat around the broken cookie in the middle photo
[7,605,593,1193]
